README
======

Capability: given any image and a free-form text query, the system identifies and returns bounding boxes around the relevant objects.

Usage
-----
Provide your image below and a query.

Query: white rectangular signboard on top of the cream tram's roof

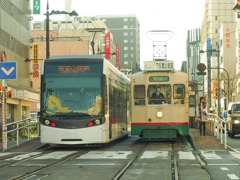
[143,61,174,71]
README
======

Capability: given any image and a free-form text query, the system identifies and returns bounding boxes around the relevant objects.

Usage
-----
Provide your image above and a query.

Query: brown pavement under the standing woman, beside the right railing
[189,128,224,151]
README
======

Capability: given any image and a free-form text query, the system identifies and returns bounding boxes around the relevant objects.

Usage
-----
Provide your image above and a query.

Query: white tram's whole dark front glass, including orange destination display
[42,61,102,117]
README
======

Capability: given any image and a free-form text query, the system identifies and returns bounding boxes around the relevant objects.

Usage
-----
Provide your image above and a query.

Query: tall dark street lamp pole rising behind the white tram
[46,1,78,59]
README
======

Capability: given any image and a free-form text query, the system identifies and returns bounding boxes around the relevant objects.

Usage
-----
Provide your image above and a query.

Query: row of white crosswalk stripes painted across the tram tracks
[0,151,240,162]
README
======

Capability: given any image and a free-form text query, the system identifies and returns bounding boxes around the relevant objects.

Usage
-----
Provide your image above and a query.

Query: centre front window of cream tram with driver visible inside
[148,84,172,104]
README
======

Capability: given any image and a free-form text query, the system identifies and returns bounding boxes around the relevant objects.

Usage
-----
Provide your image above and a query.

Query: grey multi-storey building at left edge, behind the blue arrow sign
[0,0,39,123]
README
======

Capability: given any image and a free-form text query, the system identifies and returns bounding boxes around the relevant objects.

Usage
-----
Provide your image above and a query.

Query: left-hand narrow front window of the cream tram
[134,85,145,106]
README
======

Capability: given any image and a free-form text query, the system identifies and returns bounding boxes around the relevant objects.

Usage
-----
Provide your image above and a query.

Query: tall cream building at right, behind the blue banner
[200,0,235,111]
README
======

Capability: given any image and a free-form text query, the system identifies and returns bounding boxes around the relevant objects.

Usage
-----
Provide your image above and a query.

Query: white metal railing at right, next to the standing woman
[206,113,227,149]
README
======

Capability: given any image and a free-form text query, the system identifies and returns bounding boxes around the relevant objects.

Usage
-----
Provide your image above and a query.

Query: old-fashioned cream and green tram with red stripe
[131,61,189,140]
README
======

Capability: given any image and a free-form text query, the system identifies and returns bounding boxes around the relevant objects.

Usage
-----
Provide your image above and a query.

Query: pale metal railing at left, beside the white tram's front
[2,116,40,151]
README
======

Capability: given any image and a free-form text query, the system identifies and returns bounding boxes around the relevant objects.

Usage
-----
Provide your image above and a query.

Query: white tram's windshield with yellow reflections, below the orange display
[43,77,102,116]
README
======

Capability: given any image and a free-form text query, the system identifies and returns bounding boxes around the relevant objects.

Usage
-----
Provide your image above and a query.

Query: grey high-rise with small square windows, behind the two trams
[95,15,140,71]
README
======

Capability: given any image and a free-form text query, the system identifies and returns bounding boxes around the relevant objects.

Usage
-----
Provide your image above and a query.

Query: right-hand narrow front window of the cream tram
[173,84,185,104]
